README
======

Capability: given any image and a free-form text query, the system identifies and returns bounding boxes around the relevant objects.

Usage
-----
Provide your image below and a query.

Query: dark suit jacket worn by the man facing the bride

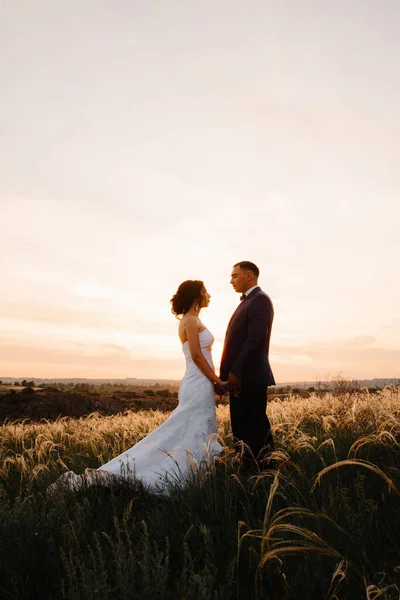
[220,287,275,385]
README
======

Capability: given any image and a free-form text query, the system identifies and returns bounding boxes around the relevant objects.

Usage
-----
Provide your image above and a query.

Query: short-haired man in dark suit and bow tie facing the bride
[220,261,275,461]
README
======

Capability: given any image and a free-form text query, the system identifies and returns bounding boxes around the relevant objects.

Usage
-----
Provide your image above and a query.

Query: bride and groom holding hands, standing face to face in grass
[51,261,275,494]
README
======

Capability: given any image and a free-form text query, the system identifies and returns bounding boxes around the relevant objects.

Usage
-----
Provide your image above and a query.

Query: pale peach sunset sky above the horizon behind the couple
[0,0,400,382]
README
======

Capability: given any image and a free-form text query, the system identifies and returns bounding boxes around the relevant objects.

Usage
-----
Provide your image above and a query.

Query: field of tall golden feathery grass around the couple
[0,387,400,600]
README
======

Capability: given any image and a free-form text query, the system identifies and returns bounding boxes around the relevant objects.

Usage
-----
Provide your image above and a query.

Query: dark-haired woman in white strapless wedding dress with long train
[49,280,227,494]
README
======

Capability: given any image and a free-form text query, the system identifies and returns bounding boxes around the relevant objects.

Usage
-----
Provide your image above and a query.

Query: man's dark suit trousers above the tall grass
[229,381,274,460]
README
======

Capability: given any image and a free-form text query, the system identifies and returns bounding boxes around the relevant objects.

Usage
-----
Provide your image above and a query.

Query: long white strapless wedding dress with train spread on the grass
[49,329,223,494]
